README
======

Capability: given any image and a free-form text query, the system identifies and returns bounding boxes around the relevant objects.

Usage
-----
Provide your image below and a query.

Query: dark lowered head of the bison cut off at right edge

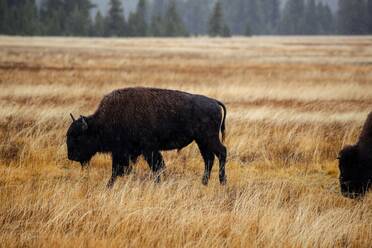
[338,145,371,198]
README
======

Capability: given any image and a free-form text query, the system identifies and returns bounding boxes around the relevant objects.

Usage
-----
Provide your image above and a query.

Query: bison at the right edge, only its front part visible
[338,112,372,198]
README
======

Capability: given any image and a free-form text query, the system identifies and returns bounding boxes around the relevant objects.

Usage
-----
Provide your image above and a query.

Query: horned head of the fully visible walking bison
[66,114,99,166]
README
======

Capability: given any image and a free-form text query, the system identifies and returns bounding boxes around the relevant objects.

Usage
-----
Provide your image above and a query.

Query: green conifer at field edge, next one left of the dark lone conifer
[163,0,188,37]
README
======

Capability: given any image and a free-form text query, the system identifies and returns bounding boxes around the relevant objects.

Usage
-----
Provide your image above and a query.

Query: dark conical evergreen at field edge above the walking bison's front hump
[105,0,128,36]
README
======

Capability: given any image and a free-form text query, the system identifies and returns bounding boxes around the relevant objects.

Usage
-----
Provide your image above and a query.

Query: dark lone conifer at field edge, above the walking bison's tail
[208,1,230,37]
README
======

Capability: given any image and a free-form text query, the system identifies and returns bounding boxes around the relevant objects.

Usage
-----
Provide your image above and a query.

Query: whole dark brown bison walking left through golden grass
[66,87,226,187]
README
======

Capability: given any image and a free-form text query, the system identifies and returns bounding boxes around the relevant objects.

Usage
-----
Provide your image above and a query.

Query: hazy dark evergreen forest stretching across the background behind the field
[0,0,372,37]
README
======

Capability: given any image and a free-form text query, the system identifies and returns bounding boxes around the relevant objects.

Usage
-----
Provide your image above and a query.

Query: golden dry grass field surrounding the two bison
[0,37,372,247]
